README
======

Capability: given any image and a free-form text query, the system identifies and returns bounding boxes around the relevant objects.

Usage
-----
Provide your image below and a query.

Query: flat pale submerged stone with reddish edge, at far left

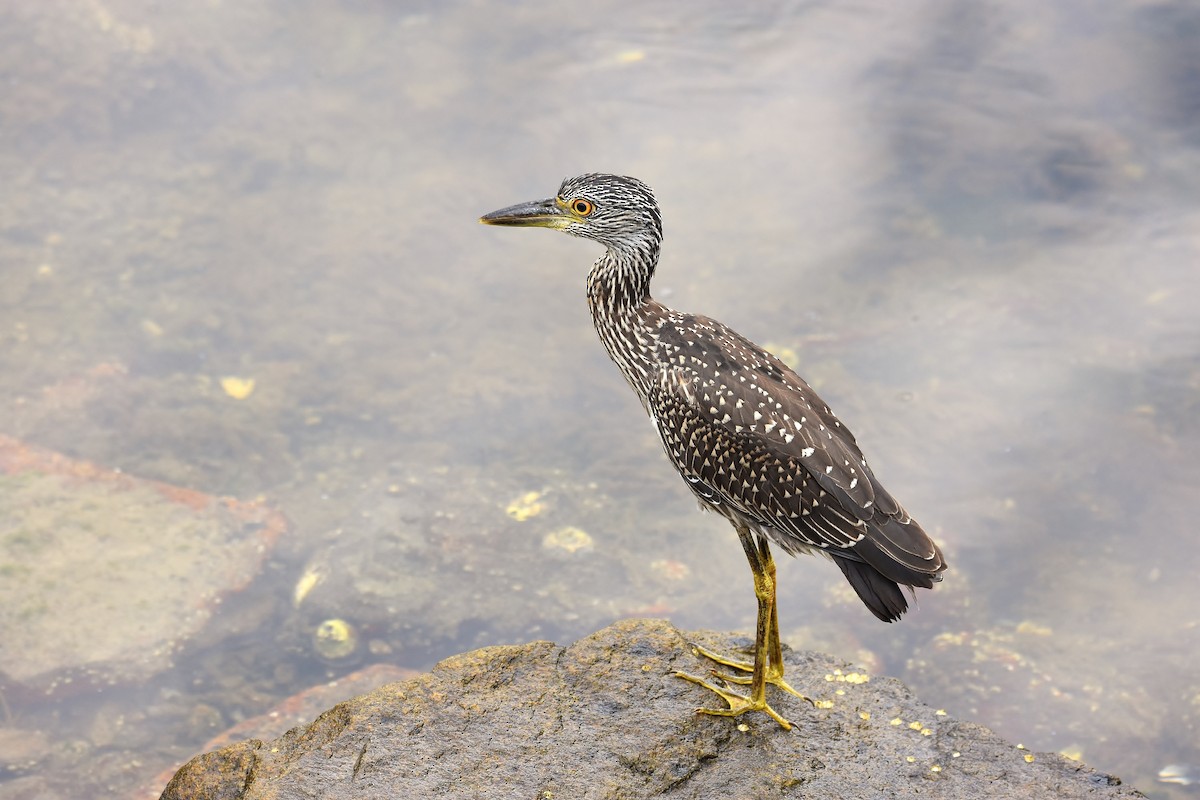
[0,437,287,699]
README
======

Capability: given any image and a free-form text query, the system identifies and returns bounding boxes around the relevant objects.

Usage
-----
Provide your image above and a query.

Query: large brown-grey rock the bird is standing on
[162,620,1142,800]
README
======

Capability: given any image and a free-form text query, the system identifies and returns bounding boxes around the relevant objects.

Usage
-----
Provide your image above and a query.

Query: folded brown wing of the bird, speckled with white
[649,314,936,568]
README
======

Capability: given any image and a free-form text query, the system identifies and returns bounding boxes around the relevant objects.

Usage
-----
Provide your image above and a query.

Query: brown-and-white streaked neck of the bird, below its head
[588,243,666,404]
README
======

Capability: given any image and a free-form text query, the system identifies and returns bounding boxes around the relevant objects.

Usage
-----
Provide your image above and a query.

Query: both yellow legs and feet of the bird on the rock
[676,525,808,729]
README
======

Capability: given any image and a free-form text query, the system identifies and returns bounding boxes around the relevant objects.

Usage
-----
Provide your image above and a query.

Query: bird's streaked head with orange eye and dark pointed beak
[479,174,662,251]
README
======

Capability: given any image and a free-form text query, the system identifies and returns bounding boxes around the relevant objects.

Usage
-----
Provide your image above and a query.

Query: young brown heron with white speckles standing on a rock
[479,173,947,729]
